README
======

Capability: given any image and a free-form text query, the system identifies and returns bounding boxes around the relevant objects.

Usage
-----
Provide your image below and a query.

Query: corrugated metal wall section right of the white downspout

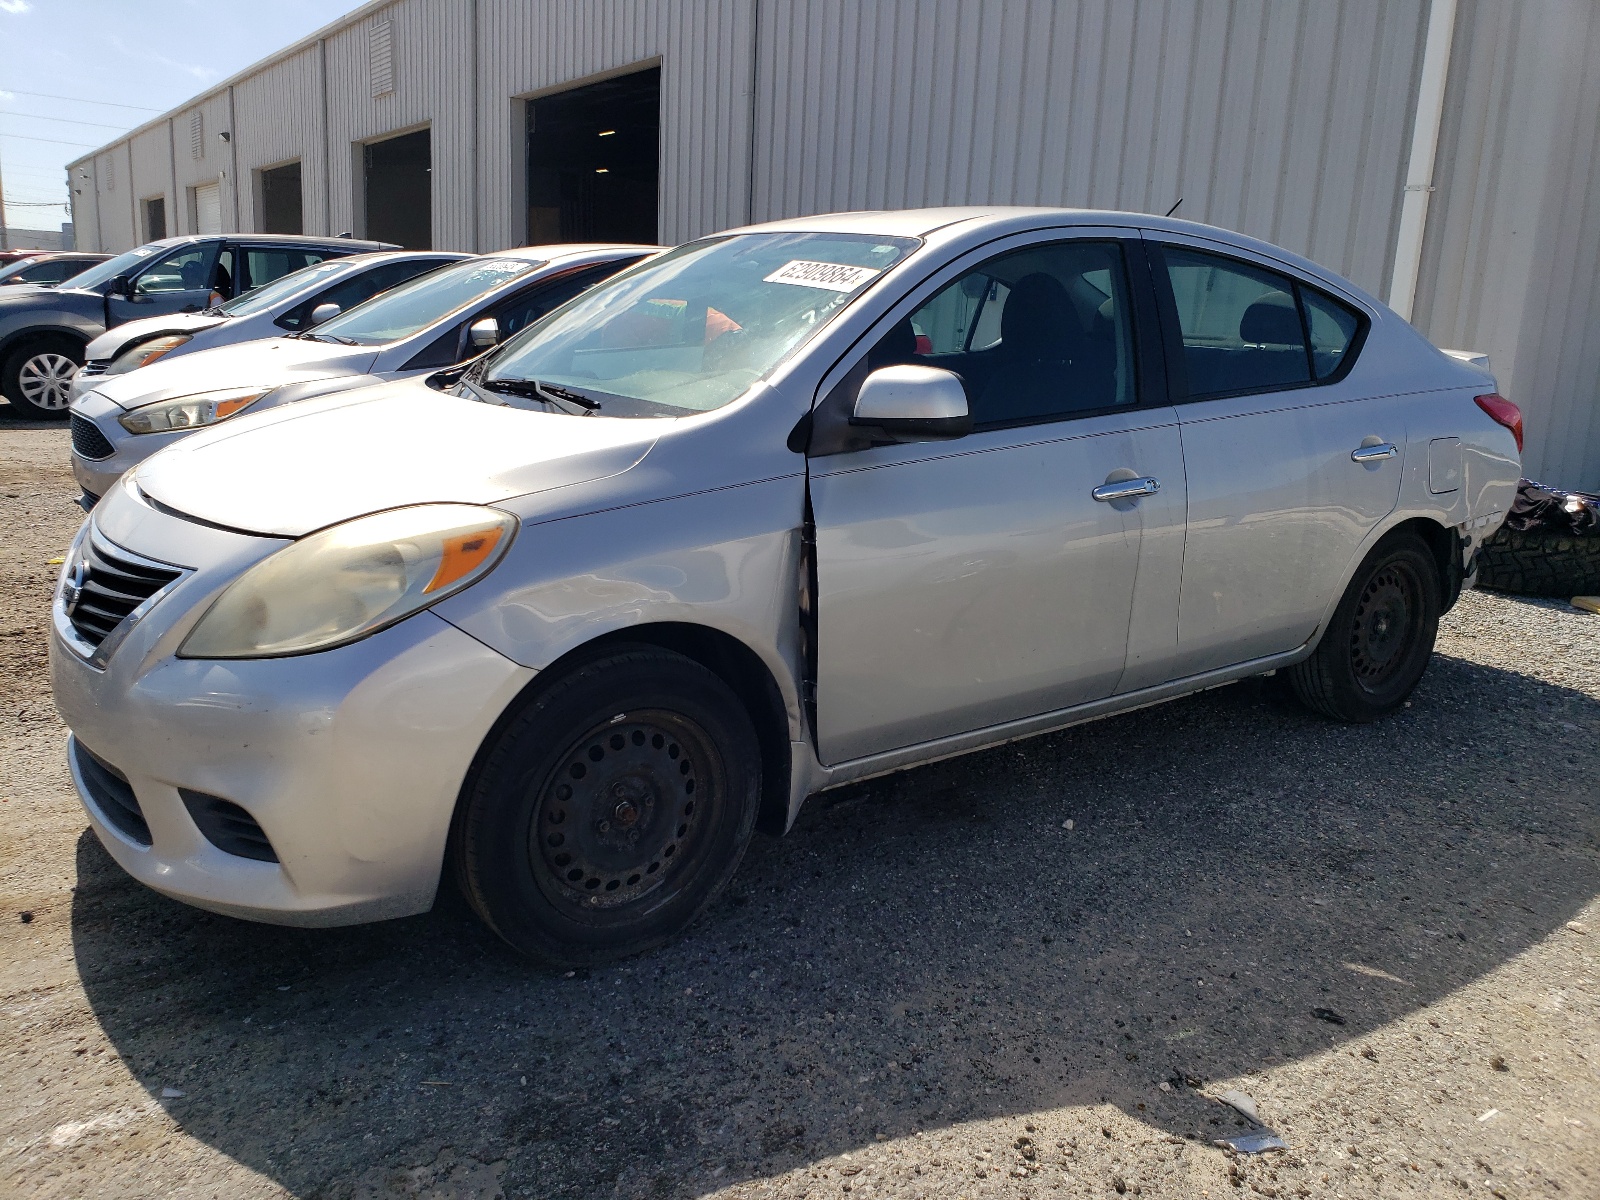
[1413,0,1600,490]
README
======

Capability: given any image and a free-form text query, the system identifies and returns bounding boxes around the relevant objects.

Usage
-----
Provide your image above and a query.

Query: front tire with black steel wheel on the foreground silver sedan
[451,646,762,968]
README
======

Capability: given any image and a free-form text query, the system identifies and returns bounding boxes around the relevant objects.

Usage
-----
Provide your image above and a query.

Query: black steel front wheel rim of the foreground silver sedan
[528,709,725,920]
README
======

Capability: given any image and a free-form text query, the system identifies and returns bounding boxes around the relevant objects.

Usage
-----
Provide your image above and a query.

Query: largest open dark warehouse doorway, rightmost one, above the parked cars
[528,67,661,245]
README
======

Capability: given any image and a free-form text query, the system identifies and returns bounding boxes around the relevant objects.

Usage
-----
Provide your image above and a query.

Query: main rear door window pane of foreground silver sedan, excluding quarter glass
[1162,246,1310,398]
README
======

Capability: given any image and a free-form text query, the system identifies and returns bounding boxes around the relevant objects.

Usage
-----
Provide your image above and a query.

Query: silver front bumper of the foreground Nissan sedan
[50,488,534,925]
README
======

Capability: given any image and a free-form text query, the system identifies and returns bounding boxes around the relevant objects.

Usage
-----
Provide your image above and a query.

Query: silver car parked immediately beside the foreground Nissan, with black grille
[70,245,661,507]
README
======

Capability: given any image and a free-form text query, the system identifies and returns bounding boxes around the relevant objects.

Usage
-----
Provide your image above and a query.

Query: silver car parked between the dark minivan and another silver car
[72,250,472,400]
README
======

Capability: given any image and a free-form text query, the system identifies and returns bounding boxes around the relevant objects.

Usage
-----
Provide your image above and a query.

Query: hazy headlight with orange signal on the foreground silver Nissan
[178,504,517,658]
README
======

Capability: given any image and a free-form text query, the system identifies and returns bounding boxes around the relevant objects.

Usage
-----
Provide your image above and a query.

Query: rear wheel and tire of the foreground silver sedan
[1288,533,1442,723]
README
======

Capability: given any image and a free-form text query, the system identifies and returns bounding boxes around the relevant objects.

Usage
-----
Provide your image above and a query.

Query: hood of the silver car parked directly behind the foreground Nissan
[94,338,378,410]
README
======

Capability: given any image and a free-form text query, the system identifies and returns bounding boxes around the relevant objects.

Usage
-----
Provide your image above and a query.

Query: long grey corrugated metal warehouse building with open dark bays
[69,0,1600,490]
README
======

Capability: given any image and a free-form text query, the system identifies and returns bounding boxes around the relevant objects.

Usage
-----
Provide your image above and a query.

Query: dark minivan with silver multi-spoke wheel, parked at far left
[0,234,398,421]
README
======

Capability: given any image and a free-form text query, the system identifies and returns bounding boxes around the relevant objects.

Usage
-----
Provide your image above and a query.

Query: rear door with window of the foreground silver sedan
[1147,234,1406,678]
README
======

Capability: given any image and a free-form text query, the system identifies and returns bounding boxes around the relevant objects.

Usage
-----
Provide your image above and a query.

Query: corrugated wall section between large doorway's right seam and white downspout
[755,0,1427,299]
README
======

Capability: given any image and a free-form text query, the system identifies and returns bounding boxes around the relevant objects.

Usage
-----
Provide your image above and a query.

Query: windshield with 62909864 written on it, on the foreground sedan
[466,234,917,416]
